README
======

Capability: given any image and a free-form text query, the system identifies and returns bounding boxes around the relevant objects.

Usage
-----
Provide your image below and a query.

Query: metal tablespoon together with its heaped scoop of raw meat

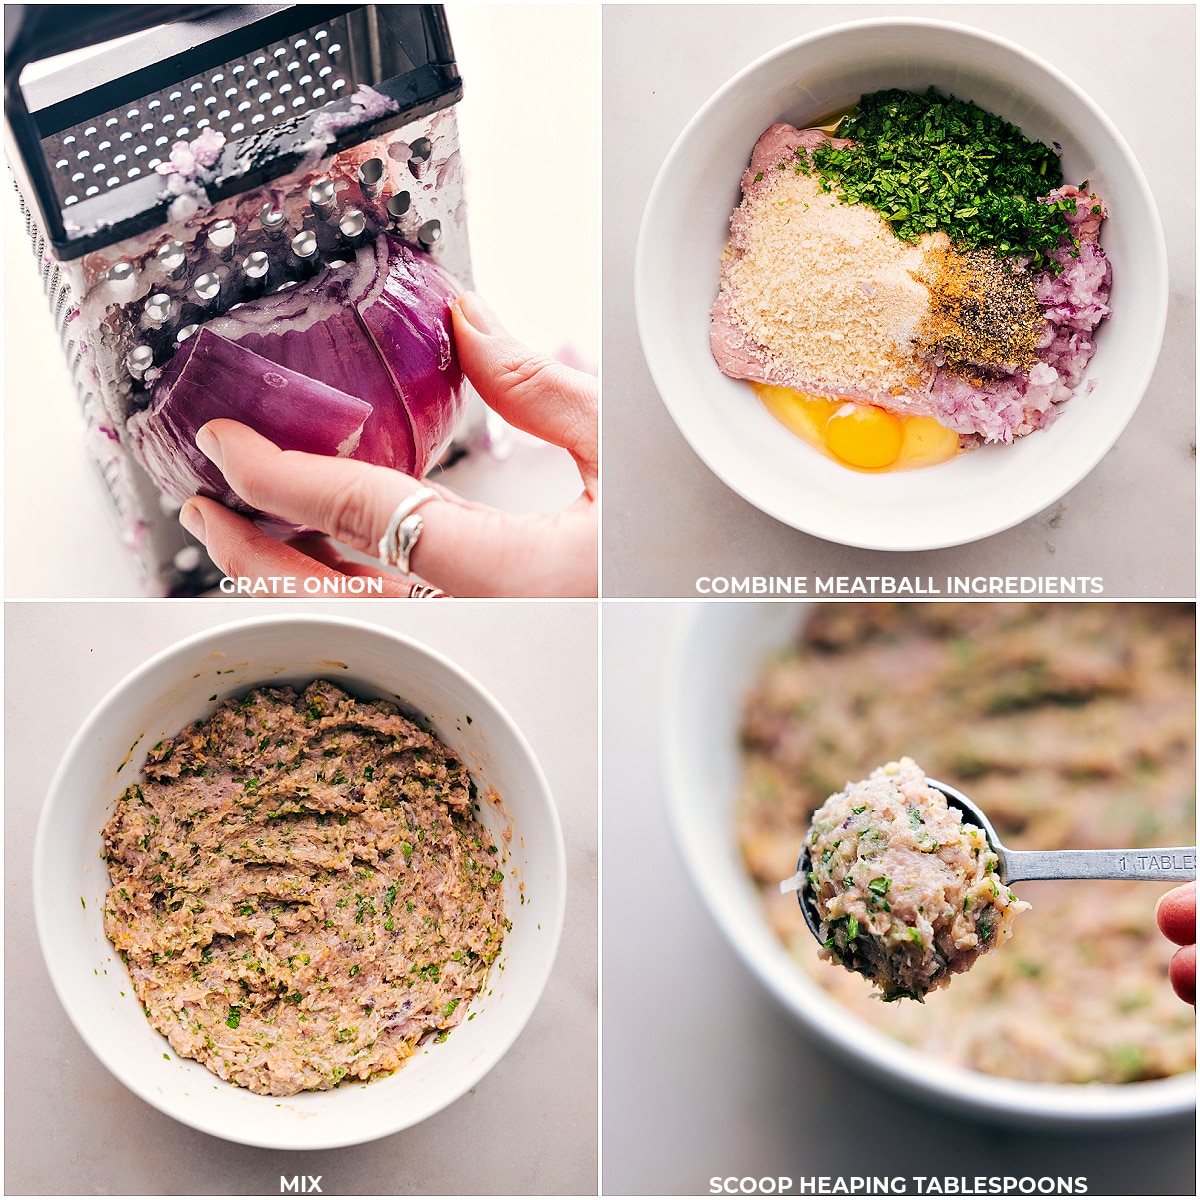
[780,758,1196,1001]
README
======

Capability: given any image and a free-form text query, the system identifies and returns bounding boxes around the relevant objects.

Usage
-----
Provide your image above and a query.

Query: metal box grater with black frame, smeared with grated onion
[5,4,470,595]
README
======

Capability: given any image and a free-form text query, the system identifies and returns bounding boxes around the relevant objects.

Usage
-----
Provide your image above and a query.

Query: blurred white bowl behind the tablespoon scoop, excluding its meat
[662,601,1195,1128]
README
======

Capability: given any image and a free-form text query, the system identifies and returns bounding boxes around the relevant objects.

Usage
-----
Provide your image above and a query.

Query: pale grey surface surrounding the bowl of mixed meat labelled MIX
[5,600,598,1195]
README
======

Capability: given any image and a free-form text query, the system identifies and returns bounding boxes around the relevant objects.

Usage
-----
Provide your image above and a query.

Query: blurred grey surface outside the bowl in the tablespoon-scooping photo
[601,601,1196,1196]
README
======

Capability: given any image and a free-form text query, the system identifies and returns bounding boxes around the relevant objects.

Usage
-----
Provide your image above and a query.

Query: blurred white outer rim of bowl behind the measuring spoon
[659,600,1196,1128]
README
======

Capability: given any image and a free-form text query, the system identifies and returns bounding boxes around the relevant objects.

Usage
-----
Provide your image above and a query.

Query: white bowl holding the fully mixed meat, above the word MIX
[34,616,566,1150]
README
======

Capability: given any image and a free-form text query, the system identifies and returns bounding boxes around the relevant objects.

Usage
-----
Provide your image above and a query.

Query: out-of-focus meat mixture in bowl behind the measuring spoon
[737,602,1196,1084]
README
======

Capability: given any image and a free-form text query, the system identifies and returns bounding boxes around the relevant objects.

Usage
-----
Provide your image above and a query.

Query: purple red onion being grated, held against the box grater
[128,233,466,534]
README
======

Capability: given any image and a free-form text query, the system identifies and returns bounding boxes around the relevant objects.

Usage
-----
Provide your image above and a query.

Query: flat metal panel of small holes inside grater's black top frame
[42,17,362,206]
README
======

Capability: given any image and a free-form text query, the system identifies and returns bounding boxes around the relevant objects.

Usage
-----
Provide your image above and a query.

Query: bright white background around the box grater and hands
[0,4,600,598]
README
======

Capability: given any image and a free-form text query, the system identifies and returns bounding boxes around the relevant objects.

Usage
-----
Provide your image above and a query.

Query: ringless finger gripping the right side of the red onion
[450,292,599,496]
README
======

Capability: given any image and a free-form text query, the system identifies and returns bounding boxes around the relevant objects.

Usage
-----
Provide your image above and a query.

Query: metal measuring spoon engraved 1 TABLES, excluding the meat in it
[796,779,1196,941]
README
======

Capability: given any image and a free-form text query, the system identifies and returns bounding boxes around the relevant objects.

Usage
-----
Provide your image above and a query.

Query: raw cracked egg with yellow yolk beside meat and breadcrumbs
[754,384,959,470]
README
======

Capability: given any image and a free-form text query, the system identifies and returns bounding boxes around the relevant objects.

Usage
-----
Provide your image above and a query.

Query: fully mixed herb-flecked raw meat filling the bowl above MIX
[103,680,505,1096]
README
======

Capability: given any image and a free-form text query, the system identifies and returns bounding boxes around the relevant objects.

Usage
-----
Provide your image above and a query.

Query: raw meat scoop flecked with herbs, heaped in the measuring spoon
[809,758,1030,1000]
